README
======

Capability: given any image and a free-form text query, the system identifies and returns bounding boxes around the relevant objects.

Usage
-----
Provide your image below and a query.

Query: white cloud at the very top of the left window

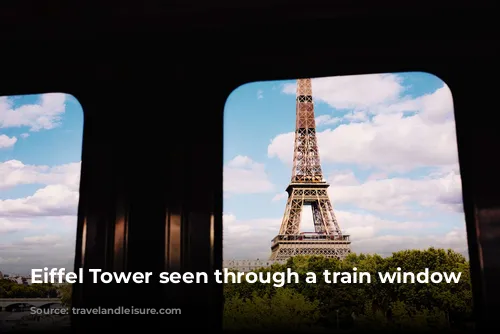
[0,93,66,131]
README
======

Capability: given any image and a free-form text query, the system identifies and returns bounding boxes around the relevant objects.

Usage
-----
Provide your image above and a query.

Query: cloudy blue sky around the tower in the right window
[224,73,467,259]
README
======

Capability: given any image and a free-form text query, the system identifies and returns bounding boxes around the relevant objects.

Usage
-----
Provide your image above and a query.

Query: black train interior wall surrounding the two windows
[0,1,500,329]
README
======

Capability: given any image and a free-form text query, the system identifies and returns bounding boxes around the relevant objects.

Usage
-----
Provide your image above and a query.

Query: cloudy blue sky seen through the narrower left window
[0,93,83,274]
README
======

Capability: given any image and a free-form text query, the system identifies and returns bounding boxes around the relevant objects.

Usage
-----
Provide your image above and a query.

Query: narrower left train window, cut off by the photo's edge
[0,93,83,333]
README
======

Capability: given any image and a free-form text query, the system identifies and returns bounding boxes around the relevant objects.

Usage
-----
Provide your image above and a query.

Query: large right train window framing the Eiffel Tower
[223,72,473,330]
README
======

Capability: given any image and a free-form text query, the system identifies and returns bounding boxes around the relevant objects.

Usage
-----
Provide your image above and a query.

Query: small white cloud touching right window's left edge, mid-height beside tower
[224,155,274,194]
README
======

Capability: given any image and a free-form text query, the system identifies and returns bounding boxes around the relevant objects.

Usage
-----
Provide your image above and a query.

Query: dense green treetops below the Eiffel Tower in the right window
[224,248,473,333]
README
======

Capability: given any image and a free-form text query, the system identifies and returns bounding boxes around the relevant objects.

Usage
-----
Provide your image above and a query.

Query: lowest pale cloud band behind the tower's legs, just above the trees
[223,211,467,260]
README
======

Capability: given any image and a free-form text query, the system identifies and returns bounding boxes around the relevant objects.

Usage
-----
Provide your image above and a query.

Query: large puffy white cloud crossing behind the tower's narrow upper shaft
[268,83,458,172]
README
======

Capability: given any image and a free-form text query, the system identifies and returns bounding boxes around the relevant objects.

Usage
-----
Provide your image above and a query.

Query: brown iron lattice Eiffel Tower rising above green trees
[269,79,351,261]
